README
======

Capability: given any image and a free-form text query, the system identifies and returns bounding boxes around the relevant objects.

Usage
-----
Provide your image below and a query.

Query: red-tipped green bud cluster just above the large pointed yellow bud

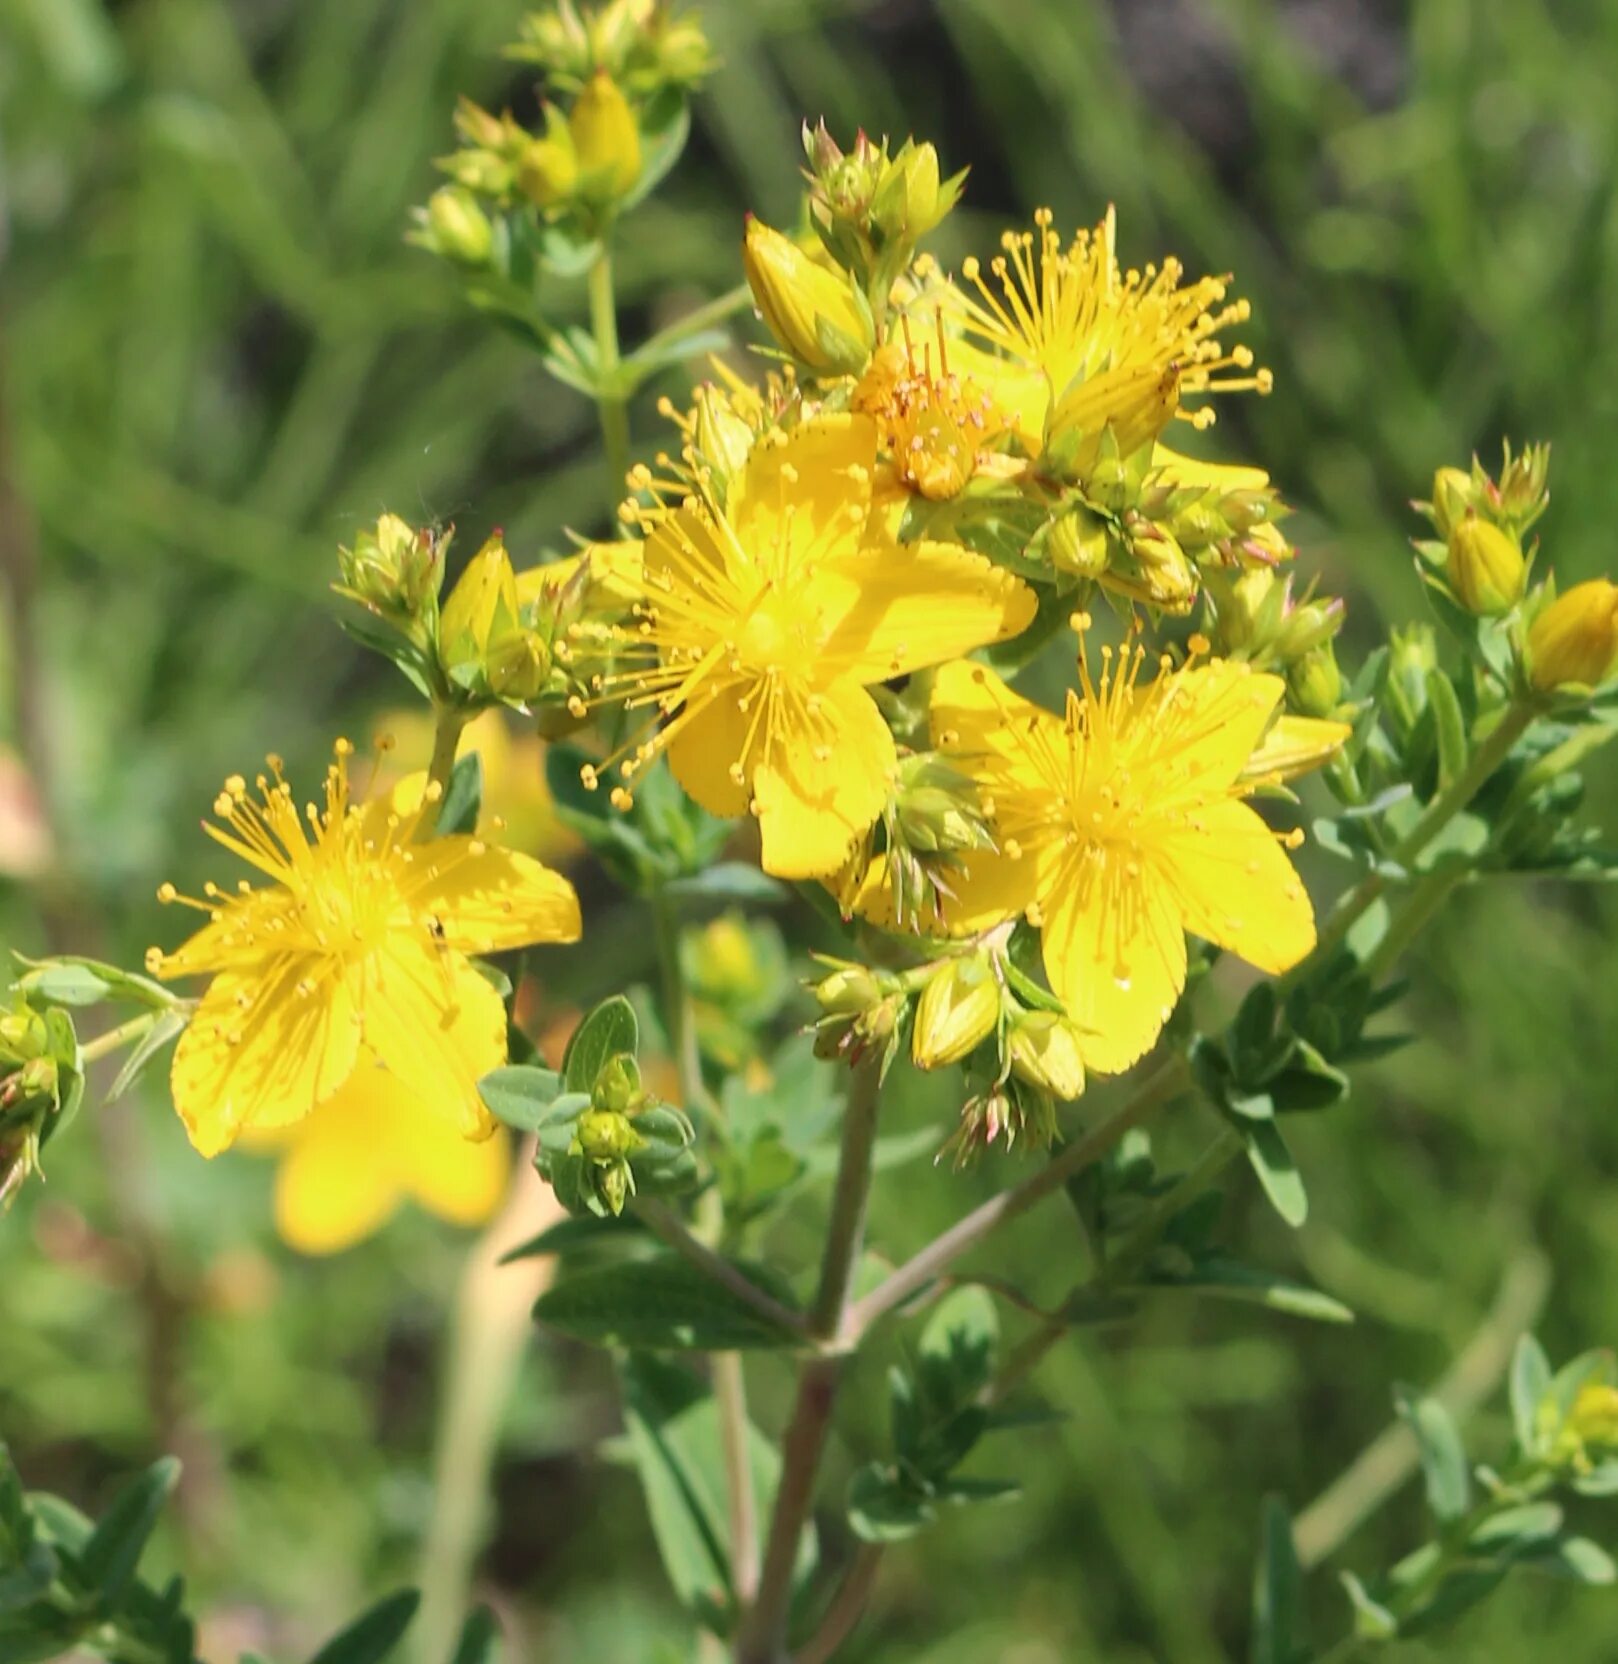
[804,121,965,306]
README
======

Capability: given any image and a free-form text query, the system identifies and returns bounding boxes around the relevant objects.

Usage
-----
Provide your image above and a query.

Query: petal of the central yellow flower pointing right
[814,542,1039,682]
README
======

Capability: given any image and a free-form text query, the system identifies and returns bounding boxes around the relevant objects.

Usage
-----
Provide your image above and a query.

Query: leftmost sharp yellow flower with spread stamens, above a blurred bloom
[146,740,579,1155]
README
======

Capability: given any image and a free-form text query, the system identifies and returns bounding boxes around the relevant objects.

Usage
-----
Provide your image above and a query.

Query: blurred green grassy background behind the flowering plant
[0,0,1618,1664]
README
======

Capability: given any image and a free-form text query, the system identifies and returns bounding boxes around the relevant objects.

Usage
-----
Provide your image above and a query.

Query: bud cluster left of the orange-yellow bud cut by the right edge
[1415,444,1550,617]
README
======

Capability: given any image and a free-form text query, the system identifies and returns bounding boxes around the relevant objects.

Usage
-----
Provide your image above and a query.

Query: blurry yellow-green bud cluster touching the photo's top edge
[506,0,714,100]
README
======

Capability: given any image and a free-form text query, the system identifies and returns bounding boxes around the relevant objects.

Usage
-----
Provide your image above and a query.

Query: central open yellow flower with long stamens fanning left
[586,416,1035,879]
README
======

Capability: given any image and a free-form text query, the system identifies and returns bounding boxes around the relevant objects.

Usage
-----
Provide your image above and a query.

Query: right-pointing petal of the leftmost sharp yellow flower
[406,835,579,953]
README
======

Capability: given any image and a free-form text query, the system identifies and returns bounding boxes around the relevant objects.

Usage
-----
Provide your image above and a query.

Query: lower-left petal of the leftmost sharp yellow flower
[170,958,359,1155]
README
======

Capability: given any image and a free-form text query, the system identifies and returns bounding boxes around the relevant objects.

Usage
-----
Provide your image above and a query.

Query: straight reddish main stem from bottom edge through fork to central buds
[736,1057,882,1664]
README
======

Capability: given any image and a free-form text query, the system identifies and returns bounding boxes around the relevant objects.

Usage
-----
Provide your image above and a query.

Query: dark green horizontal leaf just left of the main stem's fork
[534,1255,799,1351]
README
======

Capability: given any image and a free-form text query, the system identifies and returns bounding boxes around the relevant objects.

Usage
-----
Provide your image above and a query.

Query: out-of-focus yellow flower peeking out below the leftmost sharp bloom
[243,1060,511,1255]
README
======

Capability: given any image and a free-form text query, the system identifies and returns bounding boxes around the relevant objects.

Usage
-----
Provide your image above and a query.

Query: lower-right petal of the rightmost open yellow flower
[1159,802,1315,975]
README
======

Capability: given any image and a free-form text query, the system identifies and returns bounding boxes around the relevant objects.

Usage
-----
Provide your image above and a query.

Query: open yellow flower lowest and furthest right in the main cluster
[932,647,1315,1073]
